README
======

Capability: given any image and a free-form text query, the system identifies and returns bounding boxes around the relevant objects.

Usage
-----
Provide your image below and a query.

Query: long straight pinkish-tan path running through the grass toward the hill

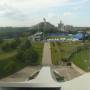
[42,42,52,65]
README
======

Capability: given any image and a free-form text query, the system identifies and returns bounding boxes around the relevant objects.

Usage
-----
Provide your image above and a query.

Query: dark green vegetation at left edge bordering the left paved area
[0,56,26,78]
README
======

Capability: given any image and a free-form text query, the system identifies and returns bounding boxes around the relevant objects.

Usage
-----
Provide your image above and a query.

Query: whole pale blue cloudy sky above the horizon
[0,0,90,27]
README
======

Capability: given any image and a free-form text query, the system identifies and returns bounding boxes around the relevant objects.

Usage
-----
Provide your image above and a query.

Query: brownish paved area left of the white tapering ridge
[0,66,41,82]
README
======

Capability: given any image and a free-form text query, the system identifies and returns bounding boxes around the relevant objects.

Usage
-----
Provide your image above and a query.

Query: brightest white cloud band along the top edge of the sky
[0,0,70,8]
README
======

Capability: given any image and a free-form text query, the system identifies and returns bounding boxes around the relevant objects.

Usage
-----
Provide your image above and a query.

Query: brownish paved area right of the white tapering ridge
[53,66,82,81]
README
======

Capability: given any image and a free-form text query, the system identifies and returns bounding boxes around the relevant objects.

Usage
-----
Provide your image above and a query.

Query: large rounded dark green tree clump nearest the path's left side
[17,48,38,64]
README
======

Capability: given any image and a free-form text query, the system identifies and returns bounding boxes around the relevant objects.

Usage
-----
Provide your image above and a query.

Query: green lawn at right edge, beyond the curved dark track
[71,48,90,71]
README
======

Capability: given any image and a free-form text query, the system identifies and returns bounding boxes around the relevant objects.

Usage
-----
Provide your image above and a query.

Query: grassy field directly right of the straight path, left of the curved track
[51,42,86,64]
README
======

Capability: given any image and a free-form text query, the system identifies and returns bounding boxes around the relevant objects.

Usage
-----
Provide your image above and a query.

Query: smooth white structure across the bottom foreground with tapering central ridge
[0,66,90,90]
